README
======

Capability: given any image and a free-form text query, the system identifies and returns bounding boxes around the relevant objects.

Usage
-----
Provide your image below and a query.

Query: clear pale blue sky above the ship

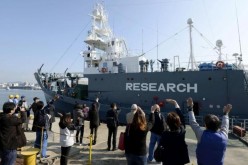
[0,0,248,82]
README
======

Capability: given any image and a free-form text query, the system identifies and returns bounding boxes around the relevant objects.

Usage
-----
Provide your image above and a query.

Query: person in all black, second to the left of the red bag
[89,103,100,145]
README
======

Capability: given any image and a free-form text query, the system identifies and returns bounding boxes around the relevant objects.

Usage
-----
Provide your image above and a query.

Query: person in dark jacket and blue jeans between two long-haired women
[147,104,166,163]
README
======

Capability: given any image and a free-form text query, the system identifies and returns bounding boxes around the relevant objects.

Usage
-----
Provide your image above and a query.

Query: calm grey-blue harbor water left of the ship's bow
[0,89,46,109]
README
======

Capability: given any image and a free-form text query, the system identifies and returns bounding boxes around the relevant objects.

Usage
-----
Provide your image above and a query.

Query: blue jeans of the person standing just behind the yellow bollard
[34,130,48,158]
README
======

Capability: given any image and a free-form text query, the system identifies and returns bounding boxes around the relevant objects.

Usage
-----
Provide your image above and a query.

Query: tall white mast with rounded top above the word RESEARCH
[187,18,197,71]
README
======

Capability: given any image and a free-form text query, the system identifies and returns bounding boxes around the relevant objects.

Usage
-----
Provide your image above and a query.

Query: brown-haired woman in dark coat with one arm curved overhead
[159,99,190,165]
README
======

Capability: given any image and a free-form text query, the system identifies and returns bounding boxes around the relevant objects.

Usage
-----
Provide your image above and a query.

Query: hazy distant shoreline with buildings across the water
[0,82,41,90]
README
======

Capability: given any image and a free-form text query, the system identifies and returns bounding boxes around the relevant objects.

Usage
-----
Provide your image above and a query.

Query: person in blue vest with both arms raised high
[187,98,232,165]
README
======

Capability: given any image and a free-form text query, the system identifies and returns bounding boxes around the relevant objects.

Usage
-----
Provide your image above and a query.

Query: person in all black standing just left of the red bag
[106,103,120,151]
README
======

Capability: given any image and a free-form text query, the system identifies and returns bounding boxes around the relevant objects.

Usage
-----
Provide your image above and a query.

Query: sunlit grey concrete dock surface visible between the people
[16,118,248,165]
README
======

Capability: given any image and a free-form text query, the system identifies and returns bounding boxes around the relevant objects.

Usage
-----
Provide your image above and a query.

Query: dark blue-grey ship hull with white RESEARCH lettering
[35,70,248,123]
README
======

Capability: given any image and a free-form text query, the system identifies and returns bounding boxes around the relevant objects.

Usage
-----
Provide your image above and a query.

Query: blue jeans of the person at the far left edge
[0,150,17,165]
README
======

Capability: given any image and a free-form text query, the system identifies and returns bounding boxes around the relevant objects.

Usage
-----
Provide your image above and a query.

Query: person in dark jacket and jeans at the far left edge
[0,102,26,165]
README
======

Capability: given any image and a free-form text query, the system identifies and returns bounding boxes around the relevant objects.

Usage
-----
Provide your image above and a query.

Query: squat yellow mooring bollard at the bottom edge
[21,148,39,165]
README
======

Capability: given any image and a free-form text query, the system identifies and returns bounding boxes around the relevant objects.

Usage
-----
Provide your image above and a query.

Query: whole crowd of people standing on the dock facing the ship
[0,96,232,165]
